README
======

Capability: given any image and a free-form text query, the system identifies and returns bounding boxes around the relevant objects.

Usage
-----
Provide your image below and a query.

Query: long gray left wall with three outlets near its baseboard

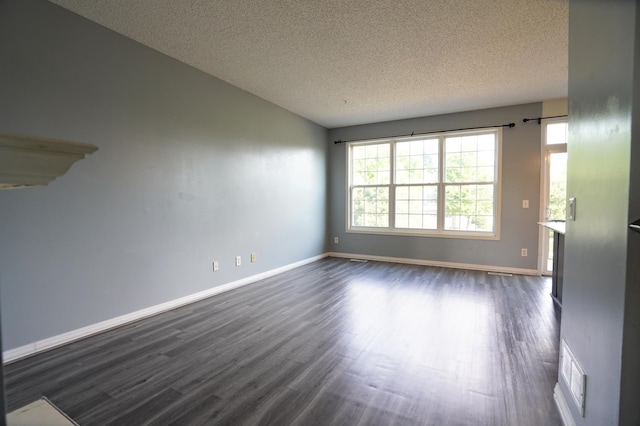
[0,0,327,350]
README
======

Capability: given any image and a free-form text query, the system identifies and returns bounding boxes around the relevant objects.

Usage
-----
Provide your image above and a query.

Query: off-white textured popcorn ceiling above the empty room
[51,0,569,128]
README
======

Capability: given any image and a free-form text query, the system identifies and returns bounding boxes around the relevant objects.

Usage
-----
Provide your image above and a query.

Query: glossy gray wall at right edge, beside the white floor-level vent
[560,0,640,426]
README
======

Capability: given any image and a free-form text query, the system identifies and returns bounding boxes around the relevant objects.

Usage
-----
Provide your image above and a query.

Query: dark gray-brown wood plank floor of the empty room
[5,259,561,426]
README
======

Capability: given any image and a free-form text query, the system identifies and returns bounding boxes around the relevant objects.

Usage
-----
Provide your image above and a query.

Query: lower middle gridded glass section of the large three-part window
[395,185,438,229]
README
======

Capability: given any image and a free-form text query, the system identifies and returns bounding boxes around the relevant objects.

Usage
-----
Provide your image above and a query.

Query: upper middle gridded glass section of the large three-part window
[395,139,439,185]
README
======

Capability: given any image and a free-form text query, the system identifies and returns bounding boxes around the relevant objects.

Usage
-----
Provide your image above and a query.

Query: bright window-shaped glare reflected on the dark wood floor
[347,280,496,391]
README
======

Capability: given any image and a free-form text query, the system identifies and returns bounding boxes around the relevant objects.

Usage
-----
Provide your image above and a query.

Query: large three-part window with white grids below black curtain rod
[347,129,501,239]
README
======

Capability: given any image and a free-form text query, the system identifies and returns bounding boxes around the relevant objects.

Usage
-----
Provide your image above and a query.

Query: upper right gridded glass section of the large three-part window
[444,133,496,183]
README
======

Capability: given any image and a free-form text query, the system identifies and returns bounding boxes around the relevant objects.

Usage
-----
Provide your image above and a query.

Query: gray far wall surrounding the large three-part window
[329,103,542,269]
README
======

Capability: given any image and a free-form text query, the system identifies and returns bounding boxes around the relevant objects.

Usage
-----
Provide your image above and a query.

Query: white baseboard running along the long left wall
[2,253,328,364]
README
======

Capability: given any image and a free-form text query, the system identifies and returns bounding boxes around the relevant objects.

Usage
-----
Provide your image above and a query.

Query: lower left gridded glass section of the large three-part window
[351,187,389,227]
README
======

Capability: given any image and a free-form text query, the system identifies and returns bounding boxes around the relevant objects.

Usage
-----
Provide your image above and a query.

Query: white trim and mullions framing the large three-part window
[345,127,502,240]
